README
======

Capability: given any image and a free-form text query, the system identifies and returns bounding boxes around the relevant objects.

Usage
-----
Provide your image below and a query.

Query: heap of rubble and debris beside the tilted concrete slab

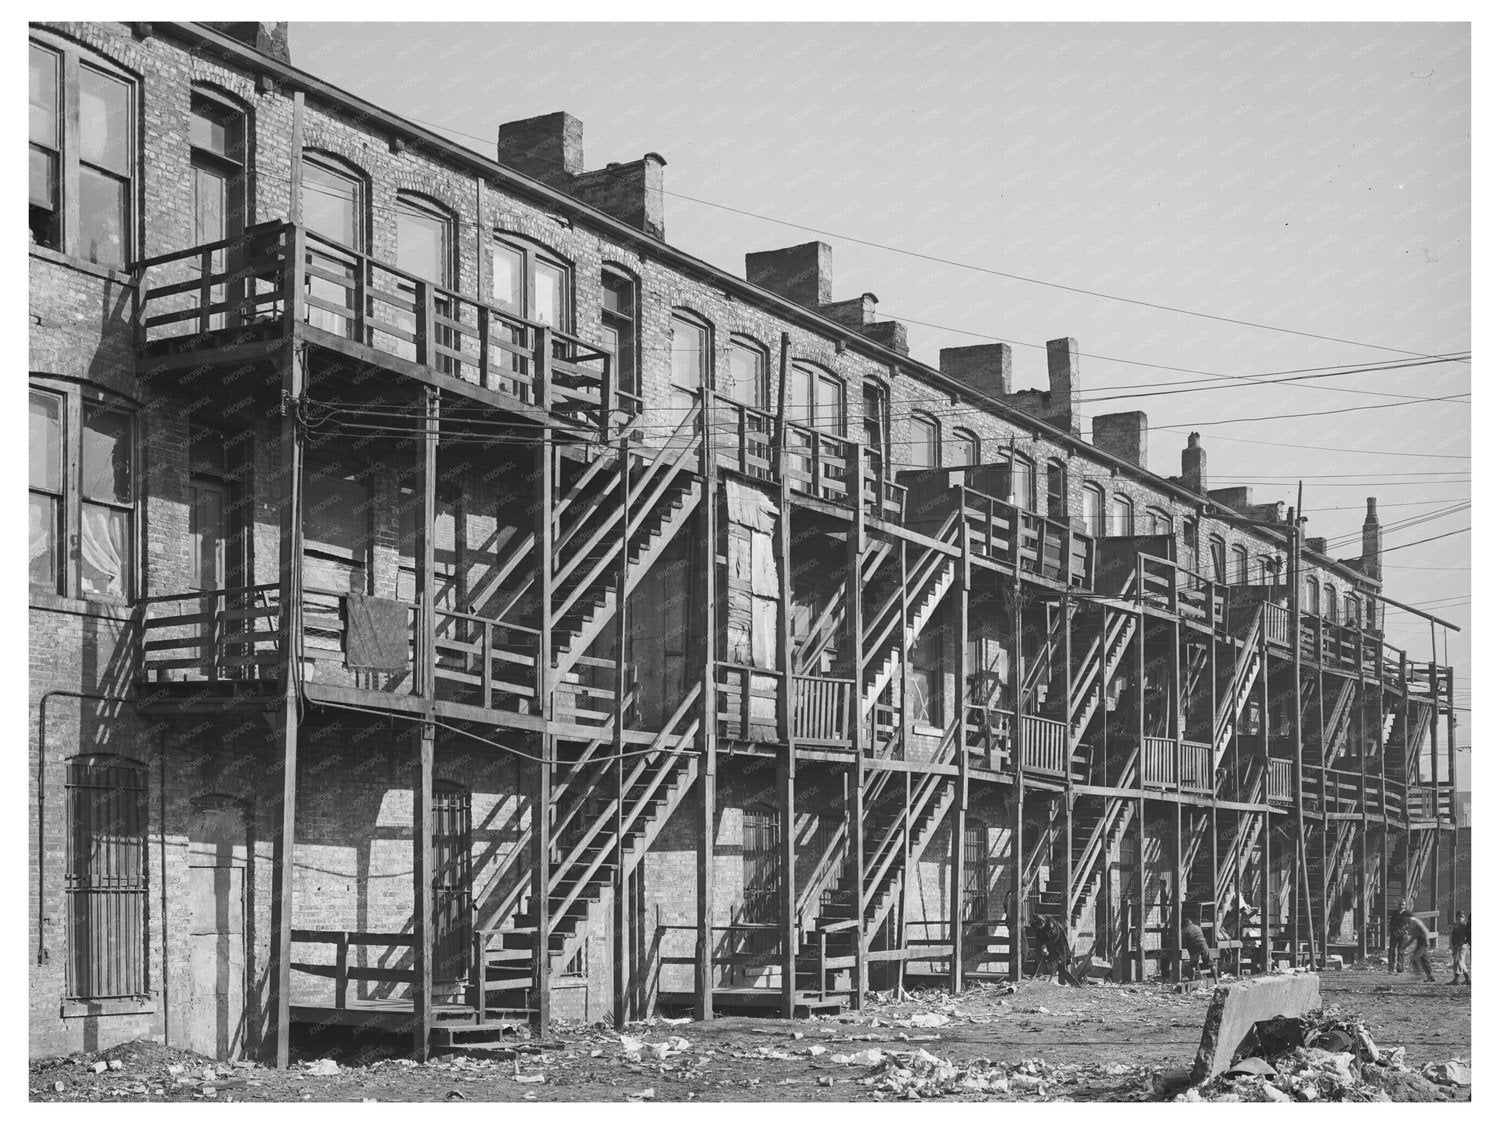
[1158,1016,1470,1103]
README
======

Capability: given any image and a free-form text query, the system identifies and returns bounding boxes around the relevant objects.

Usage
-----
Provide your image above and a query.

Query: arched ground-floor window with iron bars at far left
[63,755,147,999]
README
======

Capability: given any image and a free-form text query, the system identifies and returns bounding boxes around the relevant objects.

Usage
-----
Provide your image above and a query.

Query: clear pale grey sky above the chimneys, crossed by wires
[291,24,1470,771]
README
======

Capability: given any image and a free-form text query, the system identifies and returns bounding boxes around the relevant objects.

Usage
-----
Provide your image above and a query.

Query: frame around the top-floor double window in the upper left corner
[27,32,141,272]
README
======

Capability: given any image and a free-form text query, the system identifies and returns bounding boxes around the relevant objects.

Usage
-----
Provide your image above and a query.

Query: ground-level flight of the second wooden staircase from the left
[804,720,960,972]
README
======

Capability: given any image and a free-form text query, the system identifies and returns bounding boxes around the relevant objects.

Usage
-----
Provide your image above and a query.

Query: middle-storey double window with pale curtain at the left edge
[27,387,135,597]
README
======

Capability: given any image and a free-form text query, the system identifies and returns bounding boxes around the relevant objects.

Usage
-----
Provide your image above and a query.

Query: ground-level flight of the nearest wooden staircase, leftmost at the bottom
[485,684,702,1001]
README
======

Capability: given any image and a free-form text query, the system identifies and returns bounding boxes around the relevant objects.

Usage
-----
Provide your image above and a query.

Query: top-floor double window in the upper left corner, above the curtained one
[29,42,135,267]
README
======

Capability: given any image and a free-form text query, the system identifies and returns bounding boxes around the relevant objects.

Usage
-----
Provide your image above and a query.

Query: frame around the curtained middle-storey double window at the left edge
[27,374,144,605]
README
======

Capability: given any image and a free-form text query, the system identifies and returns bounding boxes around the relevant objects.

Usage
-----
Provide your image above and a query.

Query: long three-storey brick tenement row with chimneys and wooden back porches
[29,23,1454,1059]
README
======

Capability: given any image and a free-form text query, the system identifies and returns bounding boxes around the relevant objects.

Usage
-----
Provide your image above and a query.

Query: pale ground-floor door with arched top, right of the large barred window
[183,797,249,1061]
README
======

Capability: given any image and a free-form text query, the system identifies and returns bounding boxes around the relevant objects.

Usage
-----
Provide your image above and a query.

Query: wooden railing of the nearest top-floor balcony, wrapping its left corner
[132,224,621,432]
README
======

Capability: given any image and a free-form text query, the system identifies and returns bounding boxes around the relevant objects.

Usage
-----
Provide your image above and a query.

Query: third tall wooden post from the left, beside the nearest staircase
[531,327,557,1035]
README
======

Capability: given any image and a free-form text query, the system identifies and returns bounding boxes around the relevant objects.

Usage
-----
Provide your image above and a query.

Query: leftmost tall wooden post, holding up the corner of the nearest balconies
[270,309,308,1068]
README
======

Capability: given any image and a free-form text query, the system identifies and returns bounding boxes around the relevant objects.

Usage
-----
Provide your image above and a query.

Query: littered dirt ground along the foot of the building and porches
[30,968,1470,1101]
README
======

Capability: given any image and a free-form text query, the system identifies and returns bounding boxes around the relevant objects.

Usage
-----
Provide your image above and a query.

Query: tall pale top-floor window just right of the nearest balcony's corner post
[302,153,365,339]
